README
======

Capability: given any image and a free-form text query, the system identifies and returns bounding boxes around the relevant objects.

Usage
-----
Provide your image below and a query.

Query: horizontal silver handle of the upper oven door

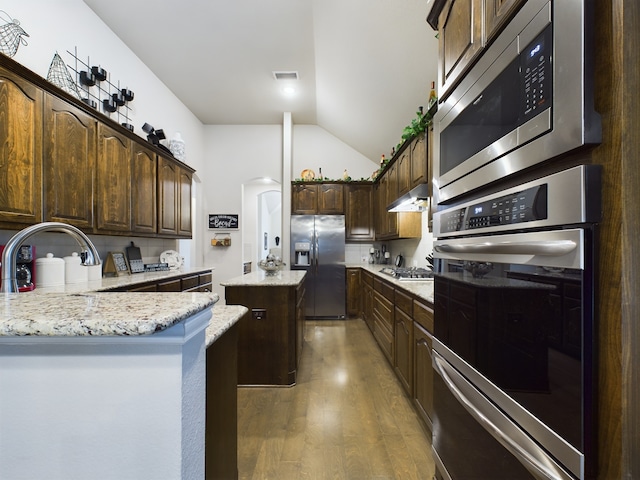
[433,240,578,256]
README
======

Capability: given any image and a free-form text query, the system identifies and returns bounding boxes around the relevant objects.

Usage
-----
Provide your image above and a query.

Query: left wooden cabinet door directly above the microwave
[438,0,483,99]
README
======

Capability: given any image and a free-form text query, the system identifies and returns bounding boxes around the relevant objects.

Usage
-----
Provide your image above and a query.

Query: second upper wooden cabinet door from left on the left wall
[43,94,97,230]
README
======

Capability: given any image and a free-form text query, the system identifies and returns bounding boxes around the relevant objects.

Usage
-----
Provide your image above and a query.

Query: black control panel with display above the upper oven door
[441,184,548,233]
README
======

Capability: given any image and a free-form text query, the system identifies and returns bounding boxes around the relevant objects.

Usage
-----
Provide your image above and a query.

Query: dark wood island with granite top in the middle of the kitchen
[221,270,306,386]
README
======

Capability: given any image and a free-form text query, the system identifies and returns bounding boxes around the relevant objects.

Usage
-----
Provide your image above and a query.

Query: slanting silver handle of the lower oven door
[432,350,573,480]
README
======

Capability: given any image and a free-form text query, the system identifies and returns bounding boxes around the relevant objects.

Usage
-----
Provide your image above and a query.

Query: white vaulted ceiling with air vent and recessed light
[84,0,437,161]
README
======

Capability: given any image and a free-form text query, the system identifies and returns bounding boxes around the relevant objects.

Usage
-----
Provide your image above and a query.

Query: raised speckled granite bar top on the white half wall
[0,289,218,337]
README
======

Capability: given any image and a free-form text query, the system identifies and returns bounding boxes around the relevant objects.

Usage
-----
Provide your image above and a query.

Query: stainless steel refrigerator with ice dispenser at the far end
[291,215,346,319]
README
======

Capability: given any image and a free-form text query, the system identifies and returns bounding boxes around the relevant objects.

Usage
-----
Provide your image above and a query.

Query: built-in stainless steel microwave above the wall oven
[433,0,601,204]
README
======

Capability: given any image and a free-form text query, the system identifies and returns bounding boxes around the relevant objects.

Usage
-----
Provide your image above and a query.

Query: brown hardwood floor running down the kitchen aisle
[238,319,434,480]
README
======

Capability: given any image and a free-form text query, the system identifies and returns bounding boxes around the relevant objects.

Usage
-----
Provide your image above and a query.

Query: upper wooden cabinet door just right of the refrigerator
[345,185,375,242]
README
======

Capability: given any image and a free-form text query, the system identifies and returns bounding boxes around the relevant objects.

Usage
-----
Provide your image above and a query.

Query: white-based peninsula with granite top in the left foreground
[0,289,246,479]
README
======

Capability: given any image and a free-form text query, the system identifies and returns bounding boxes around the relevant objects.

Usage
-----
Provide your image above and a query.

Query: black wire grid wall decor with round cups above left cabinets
[67,47,134,132]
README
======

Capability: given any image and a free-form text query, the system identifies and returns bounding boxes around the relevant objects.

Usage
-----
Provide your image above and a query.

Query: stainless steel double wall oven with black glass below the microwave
[433,165,601,480]
